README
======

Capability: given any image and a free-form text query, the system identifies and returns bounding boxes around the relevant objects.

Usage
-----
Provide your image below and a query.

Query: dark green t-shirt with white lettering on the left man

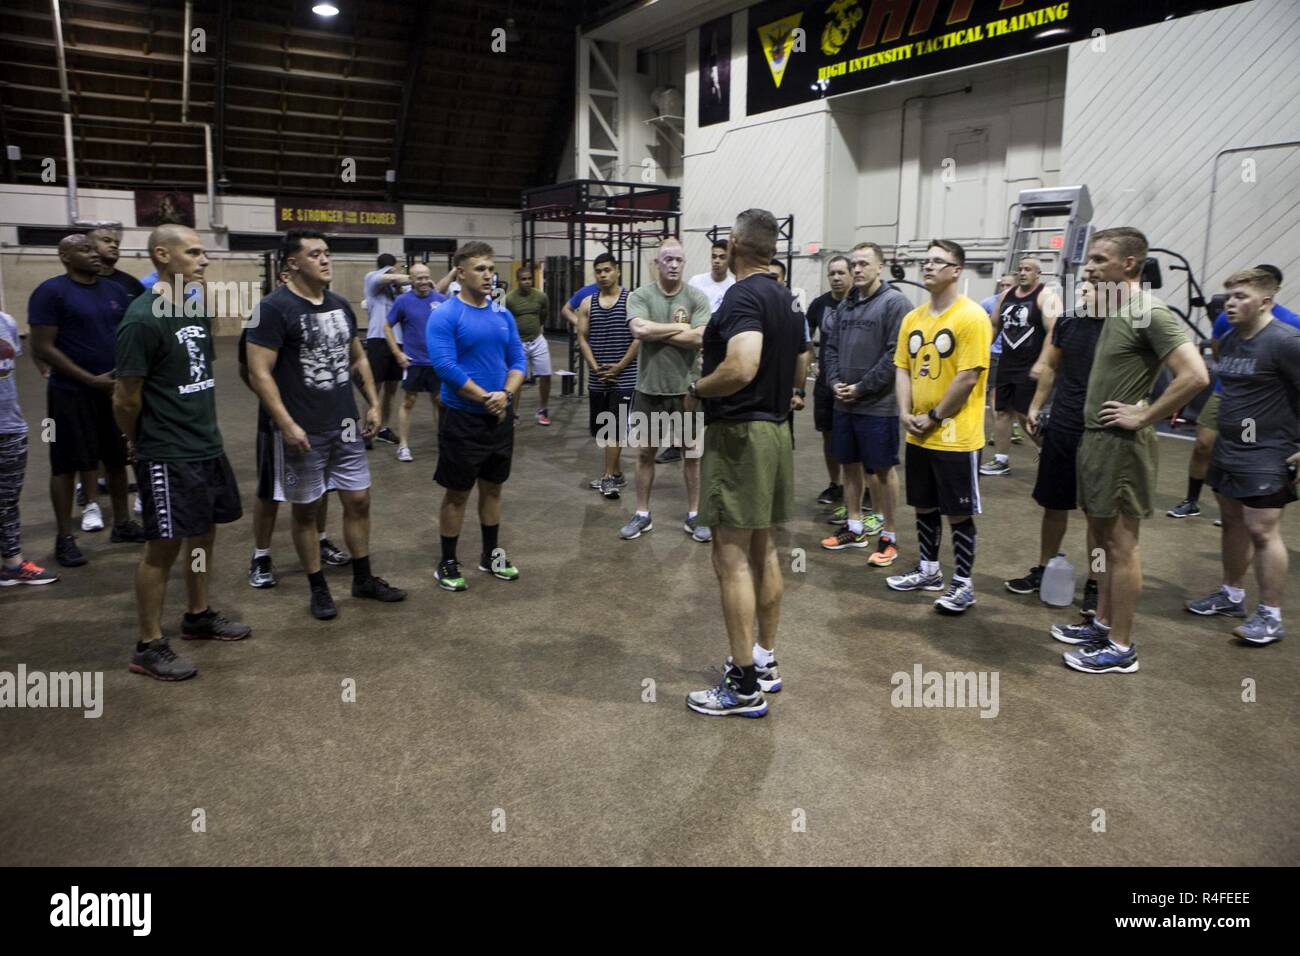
[116,294,222,462]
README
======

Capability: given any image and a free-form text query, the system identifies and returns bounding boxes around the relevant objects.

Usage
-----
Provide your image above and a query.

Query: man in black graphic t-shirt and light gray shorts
[247,230,406,620]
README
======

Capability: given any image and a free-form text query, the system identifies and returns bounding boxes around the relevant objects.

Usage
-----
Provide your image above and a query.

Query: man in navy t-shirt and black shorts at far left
[27,234,144,567]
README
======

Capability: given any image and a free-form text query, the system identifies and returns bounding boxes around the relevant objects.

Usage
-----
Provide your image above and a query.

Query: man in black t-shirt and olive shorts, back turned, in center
[686,209,809,717]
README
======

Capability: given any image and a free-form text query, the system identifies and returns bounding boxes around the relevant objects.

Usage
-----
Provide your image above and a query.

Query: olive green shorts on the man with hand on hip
[1076,428,1158,518]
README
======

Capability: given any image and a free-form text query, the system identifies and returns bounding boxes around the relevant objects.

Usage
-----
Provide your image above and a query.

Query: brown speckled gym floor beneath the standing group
[0,341,1300,865]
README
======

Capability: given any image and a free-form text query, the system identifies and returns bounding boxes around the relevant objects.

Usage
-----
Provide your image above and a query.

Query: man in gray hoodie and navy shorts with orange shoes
[822,242,911,567]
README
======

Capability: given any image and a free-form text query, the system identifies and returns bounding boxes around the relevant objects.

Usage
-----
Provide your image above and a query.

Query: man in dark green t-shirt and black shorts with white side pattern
[113,225,251,680]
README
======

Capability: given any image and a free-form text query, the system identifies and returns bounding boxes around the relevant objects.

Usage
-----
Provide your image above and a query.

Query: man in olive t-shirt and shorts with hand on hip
[1052,226,1210,674]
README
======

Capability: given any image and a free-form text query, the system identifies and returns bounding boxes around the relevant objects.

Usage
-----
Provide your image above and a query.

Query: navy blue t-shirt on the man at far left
[27,274,130,392]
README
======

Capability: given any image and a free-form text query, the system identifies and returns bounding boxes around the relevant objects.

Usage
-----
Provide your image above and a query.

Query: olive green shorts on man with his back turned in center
[699,421,794,528]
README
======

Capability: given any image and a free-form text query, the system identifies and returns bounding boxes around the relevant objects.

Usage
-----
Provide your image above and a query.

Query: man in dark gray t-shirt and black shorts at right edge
[1187,268,1300,645]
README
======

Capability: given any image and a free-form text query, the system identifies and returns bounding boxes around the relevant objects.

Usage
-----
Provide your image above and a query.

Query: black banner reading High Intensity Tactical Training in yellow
[746,0,1242,114]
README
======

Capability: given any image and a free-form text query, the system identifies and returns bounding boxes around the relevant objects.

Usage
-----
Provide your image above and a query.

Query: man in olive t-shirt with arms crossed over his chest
[619,235,712,542]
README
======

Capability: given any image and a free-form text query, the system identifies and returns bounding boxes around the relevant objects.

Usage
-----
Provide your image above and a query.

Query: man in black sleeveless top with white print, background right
[979,256,1061,475]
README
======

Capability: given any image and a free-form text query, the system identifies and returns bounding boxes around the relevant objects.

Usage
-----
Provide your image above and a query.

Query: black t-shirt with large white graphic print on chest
[248,286,358,434]
